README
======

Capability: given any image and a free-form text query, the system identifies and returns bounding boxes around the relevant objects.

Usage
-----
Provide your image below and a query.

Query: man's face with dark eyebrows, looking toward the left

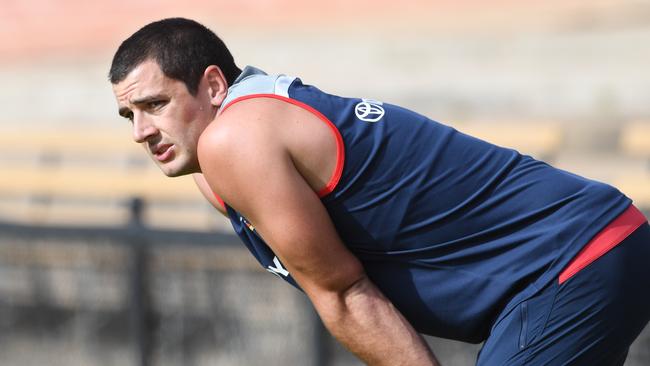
[113,60,216,177]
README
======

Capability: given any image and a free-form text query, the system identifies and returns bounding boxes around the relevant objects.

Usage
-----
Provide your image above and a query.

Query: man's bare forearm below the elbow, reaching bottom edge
[312,277,439,366]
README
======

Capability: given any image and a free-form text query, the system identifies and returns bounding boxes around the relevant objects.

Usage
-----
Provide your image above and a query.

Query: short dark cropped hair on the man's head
[108,18,241,95]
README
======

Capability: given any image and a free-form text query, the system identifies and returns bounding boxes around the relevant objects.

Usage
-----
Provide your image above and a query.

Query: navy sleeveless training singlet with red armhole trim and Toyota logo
[215,66,631,342]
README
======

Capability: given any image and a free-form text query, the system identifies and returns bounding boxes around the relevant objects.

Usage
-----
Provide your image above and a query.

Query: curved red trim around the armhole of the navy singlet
[219,94,345,198]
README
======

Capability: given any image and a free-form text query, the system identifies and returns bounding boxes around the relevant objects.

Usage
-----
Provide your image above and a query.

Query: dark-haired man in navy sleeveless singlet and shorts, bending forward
[110,19,650,365]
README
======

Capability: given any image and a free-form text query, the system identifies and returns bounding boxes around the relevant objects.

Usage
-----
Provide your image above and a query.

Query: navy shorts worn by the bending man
[477,213,650,366]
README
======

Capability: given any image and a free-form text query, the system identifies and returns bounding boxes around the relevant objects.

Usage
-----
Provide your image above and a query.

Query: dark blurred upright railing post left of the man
[127,198,154,366]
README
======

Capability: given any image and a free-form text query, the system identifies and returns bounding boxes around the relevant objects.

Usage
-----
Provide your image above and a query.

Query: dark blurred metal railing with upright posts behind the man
[0,198,331,366]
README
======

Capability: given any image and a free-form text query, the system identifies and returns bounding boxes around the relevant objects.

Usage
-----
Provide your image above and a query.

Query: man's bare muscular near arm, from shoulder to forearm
[199,98,437,365]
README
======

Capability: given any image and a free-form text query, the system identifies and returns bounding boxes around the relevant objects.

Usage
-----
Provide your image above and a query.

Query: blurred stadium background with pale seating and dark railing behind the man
[0,0,650,366]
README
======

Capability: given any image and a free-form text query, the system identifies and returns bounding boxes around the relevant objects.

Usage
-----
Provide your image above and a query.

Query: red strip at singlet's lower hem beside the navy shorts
[559,205,647,284]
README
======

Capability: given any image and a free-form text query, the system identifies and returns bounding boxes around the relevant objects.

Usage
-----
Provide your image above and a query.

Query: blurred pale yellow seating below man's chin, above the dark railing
[0,129,223,231]
